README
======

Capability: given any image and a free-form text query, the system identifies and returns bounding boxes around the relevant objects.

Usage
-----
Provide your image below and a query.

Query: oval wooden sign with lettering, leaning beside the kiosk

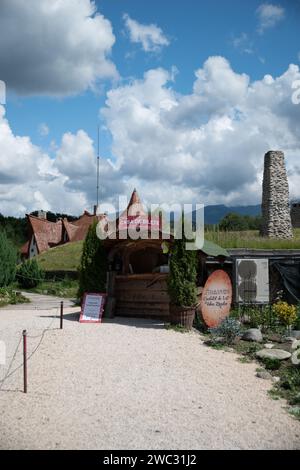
[201,269,232,328]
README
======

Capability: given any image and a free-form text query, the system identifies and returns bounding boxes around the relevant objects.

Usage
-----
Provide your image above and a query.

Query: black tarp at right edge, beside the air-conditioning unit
[271,261,300,303]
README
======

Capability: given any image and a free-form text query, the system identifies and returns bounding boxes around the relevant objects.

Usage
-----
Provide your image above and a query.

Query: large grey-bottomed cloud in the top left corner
[0,0,117,96]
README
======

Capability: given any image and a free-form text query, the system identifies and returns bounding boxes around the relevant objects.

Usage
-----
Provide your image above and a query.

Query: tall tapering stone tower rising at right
[261,151,293,239]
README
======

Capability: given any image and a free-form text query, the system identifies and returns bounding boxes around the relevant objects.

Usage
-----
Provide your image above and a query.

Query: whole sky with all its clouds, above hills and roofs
[0,0,300,216]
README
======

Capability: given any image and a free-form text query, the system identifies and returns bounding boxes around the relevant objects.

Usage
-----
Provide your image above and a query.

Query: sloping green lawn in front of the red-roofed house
[36,241,83,271]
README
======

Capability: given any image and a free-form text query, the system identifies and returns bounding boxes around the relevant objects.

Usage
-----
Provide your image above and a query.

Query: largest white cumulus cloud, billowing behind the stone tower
[102,57,300,204]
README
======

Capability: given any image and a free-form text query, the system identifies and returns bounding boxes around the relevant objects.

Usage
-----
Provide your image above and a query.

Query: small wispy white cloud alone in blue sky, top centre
[123,14,170,52]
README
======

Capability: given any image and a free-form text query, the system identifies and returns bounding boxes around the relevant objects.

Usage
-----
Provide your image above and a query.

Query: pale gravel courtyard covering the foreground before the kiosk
[0,301,300,449]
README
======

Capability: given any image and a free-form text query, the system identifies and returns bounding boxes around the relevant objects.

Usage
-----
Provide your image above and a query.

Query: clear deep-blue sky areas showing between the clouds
[7,0,300,155]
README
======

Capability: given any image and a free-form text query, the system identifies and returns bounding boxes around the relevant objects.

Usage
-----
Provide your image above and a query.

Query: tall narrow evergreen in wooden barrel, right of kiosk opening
[168,229,197,329]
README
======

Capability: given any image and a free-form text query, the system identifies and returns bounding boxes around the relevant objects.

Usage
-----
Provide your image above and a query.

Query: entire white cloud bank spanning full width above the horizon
[0,57,300,215]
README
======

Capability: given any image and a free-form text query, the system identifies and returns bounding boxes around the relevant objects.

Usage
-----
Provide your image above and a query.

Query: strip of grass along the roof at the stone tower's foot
[205,229,300,250]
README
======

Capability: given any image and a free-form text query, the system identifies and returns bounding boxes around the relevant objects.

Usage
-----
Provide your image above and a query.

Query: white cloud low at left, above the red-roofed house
[0,106,123,216]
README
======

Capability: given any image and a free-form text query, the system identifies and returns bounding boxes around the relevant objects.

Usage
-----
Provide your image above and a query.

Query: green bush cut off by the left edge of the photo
[0,232,17,287]
